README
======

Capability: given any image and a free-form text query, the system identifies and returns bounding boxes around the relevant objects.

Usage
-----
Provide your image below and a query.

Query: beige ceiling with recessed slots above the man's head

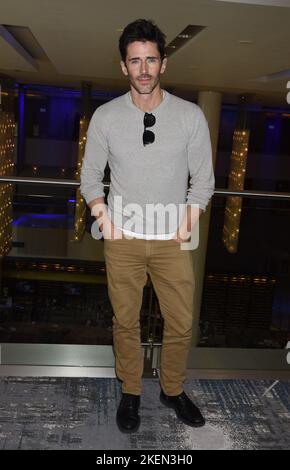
[0,0,290,103]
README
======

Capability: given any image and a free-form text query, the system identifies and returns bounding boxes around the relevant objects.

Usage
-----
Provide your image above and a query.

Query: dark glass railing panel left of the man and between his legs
[0,184,160,345]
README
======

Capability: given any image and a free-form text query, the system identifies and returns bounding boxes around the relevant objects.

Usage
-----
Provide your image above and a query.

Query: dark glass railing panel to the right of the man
[199,192,290,349]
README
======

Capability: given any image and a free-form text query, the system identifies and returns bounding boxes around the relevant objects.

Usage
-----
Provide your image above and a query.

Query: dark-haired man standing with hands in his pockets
[81,20,214,432]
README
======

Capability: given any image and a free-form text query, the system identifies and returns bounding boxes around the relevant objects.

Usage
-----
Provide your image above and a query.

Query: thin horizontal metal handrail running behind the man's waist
[0,176,290,200]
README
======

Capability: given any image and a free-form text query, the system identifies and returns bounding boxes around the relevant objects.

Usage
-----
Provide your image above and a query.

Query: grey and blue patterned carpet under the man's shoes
[0,377,290,450]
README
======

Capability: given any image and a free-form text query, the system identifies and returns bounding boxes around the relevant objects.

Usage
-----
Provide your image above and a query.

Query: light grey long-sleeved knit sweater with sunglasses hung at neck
[81,92,214,234]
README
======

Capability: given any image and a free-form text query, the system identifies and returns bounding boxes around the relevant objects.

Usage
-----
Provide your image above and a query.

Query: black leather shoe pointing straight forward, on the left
[117,393,140,433]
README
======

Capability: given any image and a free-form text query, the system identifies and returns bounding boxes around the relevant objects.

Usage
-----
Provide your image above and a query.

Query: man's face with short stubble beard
[121,41,167,94]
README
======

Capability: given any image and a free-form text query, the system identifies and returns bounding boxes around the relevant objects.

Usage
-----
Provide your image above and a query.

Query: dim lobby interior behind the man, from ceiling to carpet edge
[0,0,290,414]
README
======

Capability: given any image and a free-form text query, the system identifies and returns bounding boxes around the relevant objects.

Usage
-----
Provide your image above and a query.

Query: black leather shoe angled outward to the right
[160,390,205,428]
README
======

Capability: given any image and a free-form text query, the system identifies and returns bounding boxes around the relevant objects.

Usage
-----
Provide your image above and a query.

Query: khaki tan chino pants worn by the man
[104,238,194,395]
